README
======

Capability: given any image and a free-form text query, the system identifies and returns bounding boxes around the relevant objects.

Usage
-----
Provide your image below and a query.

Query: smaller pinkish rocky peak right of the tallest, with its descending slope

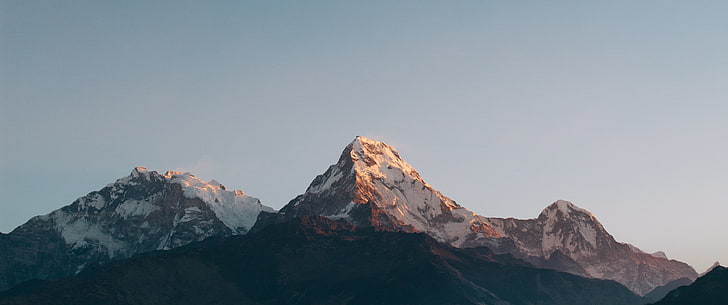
[488,201,697,295]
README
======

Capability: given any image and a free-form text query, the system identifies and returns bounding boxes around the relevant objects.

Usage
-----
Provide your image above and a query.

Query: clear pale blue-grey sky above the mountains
[0,0,728,272]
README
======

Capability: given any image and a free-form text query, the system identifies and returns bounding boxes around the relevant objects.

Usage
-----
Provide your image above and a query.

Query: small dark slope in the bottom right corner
[654,266,728,305]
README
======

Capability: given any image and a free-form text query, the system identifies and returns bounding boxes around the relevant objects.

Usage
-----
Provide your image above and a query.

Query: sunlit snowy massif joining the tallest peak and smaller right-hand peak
[256,137,697,295]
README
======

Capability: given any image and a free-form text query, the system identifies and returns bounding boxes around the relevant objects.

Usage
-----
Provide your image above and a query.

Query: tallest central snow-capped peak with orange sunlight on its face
[281,137,498,245]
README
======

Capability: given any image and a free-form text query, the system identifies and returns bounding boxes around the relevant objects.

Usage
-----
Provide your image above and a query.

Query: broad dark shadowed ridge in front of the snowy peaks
[0,217,642,305]
